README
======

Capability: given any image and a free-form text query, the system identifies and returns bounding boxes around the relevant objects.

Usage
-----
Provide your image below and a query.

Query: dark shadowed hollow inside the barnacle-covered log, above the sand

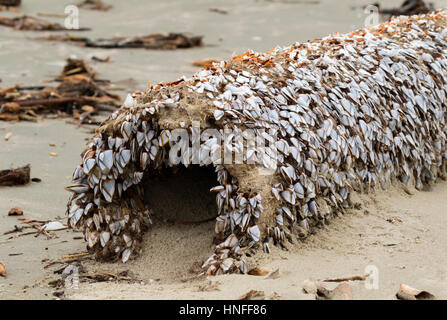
[143,165,218,224]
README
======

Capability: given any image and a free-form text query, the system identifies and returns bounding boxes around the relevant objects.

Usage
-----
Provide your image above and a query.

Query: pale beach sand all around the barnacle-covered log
[0,0,447,299]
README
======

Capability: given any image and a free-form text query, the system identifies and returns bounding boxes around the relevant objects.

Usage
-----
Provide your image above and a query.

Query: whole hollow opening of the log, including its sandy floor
[132,165,219,282]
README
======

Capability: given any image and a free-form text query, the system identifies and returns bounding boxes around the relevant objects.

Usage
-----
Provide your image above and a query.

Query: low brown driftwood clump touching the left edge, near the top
[0,15,90,31]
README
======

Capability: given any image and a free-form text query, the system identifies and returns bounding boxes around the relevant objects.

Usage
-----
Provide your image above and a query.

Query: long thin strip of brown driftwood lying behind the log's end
[36,33,203,50]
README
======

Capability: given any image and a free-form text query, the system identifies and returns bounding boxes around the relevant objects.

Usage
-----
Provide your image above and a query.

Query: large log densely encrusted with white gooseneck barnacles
[68,10,447,274]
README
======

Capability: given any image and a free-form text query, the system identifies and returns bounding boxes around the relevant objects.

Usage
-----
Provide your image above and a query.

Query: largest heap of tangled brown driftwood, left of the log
[0,58,121,124]
